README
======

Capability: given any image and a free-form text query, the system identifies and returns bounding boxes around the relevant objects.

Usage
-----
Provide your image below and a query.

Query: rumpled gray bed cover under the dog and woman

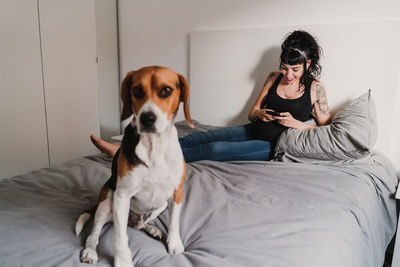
[0,123,398,267]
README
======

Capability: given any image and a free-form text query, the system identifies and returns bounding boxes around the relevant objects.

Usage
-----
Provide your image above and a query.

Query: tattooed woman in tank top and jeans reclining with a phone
[91,31,331,162]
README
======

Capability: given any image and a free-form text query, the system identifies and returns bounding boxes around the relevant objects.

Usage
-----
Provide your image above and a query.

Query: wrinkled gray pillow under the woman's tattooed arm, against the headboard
[275,90,377,162]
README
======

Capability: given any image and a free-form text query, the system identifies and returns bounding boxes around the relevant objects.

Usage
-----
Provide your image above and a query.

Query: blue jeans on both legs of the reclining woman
[179,126,271,162]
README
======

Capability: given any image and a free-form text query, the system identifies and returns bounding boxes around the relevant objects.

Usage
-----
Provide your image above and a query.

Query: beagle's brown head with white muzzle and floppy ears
[121,66,193,133]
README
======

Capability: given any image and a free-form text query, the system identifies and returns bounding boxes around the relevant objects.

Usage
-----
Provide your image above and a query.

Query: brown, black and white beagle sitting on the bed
[75,66,193,267]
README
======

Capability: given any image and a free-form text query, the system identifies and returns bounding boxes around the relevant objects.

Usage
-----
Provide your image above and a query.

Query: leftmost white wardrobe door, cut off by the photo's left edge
[0,0,49,179]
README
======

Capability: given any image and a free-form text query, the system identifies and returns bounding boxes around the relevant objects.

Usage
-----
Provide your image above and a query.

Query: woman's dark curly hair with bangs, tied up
[280,30,322,87]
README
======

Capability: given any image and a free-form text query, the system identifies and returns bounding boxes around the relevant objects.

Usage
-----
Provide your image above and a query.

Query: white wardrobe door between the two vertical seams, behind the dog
[39,0,100,164]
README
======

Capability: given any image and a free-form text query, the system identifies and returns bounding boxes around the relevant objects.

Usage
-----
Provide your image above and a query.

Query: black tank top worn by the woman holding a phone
[246,73,313,143]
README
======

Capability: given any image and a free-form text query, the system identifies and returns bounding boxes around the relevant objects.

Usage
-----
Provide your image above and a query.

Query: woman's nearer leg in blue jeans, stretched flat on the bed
[182,140,271,162]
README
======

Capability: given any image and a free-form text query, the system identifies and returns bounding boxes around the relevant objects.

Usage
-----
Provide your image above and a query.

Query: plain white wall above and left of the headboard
[118,0,400,170]
